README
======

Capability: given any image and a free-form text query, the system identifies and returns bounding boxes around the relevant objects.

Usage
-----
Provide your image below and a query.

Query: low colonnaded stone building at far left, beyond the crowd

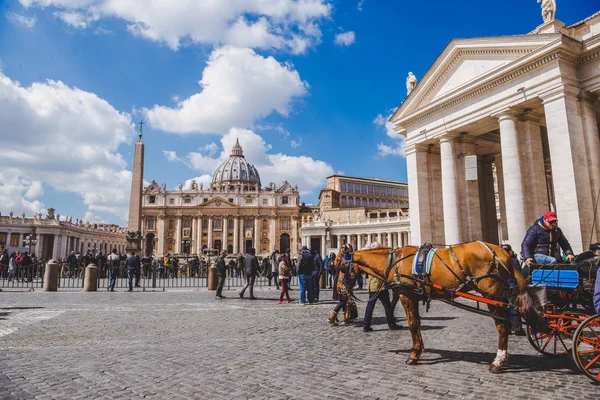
[0,208,127,260]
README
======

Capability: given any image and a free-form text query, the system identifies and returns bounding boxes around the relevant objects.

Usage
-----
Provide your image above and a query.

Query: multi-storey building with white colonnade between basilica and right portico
[300,175,410,254]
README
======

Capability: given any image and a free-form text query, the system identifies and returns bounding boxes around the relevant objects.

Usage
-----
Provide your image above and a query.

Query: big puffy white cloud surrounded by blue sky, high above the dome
[145,46,308,134]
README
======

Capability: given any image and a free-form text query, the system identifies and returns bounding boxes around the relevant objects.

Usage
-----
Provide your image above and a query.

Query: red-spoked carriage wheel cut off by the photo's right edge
[573,314,600,382]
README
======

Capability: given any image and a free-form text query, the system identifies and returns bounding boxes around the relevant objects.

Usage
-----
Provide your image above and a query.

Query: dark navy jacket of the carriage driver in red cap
[521,217,573,260]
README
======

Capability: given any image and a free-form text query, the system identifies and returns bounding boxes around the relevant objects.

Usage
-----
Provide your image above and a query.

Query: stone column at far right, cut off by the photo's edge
[579,92,600,242]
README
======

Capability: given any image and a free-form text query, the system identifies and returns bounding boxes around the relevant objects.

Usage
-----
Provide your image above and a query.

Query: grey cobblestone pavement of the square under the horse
[0,288,600,400]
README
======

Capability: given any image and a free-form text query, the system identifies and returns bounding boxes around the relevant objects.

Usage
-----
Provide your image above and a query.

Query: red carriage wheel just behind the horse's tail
[527,311,587,357]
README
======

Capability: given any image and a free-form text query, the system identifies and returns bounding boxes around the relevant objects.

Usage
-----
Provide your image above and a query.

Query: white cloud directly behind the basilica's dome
[164,128,334,195]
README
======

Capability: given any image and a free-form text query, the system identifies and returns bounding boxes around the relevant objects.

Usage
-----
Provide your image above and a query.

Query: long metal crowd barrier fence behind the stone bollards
[0,261,298,291]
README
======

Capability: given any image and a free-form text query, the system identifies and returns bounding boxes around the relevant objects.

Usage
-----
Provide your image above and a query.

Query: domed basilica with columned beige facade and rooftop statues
[142,141,301,256]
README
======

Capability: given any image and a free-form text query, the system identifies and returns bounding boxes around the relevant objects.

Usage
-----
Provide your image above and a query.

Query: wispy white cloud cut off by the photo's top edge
[19,0,332,53]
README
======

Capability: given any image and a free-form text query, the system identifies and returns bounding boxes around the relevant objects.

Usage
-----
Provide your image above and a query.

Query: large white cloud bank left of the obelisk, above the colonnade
[0,73,133,219]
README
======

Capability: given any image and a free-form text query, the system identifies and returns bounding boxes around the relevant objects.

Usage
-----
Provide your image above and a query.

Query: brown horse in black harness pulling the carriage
[336,242,545,373]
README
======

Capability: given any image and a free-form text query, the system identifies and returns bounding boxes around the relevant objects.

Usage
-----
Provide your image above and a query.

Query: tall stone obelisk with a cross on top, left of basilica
[127,121,144,253]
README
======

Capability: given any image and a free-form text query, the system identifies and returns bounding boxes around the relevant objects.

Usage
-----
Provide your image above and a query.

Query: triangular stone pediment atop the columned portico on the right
[392,35,554,121]
